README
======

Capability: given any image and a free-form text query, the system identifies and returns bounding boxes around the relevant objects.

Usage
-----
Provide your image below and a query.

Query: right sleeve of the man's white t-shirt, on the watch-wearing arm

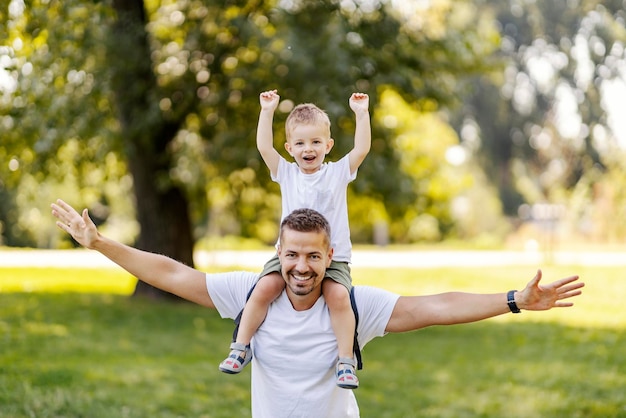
[354,286,400,347]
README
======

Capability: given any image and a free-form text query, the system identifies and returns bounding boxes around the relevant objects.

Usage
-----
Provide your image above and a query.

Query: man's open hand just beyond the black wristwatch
[515,270,585,311]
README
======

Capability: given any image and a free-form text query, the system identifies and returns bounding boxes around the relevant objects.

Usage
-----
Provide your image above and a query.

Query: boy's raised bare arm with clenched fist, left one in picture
[256,90,280,176]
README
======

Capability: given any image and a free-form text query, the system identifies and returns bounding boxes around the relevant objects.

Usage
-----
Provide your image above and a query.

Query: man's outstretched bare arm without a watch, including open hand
[51,199,215,308]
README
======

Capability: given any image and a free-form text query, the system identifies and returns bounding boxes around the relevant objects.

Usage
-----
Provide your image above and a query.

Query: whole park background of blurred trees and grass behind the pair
[0,0,626,417]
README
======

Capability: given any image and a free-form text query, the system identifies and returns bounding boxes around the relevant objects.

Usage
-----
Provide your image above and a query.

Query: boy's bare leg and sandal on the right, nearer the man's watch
[322,278,359,389]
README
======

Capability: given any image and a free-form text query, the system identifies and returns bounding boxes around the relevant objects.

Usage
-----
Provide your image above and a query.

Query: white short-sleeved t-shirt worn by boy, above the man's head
[272,155,357,263]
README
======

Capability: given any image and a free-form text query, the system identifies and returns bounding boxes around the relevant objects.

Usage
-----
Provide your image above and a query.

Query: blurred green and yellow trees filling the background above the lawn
[0,0,626,292]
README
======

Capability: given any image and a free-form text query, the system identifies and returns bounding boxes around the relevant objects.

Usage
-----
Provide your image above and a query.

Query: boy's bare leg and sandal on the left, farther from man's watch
[219,273,285,374]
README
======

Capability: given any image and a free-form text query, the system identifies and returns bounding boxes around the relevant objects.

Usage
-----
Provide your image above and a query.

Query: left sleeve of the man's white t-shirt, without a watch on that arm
[206,271,258,319]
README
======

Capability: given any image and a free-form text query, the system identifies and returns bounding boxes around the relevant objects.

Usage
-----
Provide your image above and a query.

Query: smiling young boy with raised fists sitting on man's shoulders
[220,90,371,389]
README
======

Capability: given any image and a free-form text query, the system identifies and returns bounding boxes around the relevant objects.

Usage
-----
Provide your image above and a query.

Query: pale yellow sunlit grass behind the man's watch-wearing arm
[352,266,626,329]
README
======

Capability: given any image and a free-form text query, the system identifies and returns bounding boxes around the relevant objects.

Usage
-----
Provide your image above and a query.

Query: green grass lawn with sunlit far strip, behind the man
[0,267,626,418]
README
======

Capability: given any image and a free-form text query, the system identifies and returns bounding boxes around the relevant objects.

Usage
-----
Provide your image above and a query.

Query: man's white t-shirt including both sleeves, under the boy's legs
[206,272,399,418]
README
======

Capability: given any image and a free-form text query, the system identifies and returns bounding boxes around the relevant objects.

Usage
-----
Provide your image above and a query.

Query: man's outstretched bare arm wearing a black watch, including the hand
[386,270,585,332]
